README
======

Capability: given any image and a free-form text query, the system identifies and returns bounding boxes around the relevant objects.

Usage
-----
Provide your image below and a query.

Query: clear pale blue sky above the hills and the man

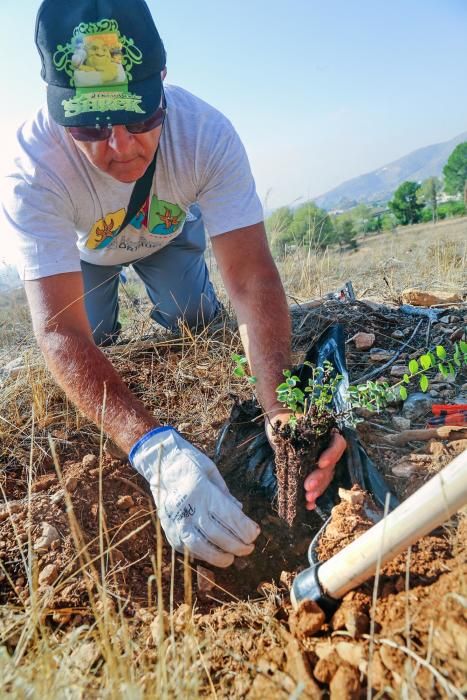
[0,0,467,262]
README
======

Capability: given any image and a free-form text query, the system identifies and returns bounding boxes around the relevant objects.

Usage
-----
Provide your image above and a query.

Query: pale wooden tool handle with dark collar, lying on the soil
[291,450,467,615]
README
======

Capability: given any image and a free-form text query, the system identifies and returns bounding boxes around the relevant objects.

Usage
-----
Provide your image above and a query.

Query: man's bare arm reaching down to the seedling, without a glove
[212,223,291,419]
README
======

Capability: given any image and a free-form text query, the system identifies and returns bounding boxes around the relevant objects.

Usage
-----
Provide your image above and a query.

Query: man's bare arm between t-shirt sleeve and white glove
[25,272,159,453]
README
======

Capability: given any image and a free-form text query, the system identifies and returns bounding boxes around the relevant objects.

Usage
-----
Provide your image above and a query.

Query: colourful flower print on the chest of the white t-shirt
[86,197,187,250]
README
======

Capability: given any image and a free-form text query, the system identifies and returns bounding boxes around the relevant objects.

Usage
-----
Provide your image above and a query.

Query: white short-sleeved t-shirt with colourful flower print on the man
[3,86,263,280]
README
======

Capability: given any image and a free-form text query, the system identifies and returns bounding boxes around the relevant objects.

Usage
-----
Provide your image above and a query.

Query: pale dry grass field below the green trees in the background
[279,213,467,302]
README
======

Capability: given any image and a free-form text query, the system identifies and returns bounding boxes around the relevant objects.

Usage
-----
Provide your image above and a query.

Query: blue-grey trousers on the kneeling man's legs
[81,207,220,345]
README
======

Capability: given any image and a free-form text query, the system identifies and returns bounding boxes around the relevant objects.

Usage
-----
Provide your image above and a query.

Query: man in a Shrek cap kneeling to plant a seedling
[1,0,345,566]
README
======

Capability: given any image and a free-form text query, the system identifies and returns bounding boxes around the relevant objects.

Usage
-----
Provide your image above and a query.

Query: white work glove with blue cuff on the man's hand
[130,426,260,567]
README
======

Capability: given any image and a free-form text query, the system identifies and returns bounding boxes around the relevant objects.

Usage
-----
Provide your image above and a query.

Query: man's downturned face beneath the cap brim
[72,126,162,182]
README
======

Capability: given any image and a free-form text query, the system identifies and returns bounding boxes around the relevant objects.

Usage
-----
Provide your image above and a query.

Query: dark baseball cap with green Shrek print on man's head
[35,0,166,126]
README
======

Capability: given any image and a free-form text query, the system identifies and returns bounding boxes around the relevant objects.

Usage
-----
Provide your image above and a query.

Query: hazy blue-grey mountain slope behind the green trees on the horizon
[315,131,467,210]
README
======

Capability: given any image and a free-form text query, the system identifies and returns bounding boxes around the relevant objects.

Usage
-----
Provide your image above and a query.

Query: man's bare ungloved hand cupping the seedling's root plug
[265,409,347,510]
